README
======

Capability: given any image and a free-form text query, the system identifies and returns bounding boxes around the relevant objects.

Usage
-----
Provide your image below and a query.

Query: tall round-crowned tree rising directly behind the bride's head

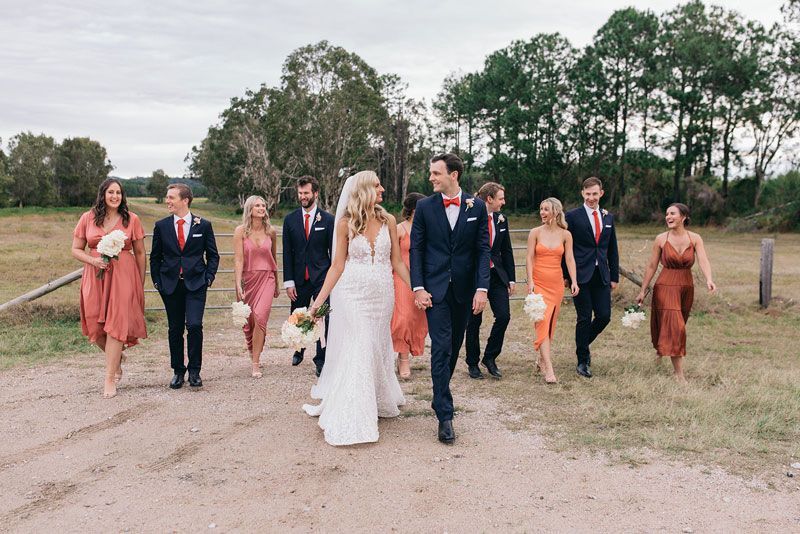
[265,41,388,207]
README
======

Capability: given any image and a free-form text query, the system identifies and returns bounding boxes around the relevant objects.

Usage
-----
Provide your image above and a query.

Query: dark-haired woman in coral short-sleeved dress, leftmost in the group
[72,178,147,398]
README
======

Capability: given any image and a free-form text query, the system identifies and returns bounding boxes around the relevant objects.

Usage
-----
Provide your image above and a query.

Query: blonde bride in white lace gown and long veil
[303,171,411,445]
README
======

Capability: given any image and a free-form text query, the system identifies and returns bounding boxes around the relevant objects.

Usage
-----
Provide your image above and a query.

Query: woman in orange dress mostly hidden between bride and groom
[392,193,428,379]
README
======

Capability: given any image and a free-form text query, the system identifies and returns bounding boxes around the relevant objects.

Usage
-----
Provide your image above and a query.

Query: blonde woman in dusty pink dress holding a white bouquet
[233,195,279,378]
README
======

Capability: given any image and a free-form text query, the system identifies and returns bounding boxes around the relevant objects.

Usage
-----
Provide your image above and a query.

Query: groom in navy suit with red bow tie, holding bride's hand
[410,154,489,444]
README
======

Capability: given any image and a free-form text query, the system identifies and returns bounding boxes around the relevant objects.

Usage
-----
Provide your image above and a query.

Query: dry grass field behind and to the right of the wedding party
[0,199,800,473]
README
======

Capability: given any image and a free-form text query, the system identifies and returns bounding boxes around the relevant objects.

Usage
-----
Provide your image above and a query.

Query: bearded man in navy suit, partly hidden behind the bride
[283,176,334,376]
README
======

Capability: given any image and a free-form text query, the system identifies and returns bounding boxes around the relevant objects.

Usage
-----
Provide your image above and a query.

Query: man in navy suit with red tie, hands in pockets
[150,184,219,389]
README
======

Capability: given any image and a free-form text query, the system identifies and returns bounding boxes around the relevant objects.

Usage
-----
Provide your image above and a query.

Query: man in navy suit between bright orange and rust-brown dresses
[562,177,619,378]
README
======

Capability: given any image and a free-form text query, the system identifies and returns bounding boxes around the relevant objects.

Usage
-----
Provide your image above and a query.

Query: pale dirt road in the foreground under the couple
[0,330,800,532]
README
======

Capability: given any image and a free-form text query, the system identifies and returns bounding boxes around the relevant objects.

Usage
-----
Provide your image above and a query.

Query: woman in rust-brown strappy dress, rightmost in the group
[636,203,717,382]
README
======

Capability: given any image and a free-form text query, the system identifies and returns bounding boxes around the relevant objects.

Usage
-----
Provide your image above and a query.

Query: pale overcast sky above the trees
[0,0,782,177]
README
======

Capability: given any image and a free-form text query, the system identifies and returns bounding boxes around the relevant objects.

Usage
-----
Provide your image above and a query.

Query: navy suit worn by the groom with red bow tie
[410,192,489,421]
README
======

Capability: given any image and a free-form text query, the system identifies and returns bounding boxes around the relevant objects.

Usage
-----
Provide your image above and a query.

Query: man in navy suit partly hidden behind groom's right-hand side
[466,182,516,379]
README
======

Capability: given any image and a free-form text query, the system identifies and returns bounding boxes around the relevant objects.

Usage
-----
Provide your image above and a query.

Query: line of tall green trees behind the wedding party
[192,0,800,228]
